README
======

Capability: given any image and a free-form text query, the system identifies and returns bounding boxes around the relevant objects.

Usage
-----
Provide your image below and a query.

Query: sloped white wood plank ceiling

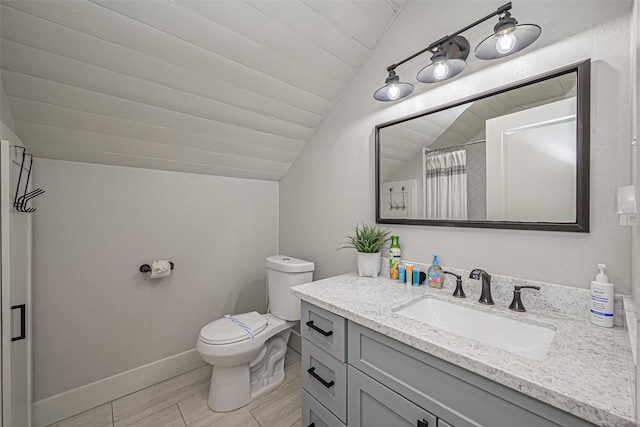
[0,0,405,180]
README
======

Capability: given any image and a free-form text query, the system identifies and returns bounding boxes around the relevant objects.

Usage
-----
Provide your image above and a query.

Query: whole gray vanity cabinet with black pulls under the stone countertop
[301,302,594,427]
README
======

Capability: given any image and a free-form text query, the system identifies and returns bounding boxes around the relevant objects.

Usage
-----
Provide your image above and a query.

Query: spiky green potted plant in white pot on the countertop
[339,224,391,277]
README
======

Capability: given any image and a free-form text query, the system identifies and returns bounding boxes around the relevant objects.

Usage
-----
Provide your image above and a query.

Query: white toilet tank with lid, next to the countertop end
[267,255,315,320]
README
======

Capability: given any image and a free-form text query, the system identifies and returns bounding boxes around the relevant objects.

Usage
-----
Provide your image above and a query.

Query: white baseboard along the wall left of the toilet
[33,348,205,427]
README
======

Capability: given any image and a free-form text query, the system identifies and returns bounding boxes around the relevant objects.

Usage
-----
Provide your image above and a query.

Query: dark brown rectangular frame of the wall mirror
[375,59,591,233]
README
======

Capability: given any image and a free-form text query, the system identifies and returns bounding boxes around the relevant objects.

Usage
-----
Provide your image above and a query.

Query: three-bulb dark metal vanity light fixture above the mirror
[373,2,542,101]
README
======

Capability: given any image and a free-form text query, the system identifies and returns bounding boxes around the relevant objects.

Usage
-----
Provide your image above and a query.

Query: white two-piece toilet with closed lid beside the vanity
[196,255,314,412]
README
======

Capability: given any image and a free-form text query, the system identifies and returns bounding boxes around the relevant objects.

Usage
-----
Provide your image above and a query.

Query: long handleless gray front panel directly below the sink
[349,322,593,427]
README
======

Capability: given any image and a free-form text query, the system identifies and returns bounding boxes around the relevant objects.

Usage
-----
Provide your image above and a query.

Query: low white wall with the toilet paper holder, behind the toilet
[33,159,278,401]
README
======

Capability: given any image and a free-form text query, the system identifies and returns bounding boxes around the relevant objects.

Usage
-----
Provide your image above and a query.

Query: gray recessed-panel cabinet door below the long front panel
[348,366,437,427]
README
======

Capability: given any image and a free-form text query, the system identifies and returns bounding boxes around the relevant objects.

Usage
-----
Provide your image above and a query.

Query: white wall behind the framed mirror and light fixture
[280,2,631,293]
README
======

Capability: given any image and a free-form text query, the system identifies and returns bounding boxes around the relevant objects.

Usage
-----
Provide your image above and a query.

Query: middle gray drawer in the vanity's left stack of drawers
[302,339,347,423]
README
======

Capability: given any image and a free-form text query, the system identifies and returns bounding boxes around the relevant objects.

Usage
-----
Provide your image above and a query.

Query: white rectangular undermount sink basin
[393,298,555,360]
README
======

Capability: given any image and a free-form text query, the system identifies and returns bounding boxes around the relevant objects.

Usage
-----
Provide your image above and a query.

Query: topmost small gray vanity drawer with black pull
[300,301,347,362]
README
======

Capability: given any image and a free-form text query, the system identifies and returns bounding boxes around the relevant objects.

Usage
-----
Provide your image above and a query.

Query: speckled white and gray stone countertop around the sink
[291,269,636,427]
